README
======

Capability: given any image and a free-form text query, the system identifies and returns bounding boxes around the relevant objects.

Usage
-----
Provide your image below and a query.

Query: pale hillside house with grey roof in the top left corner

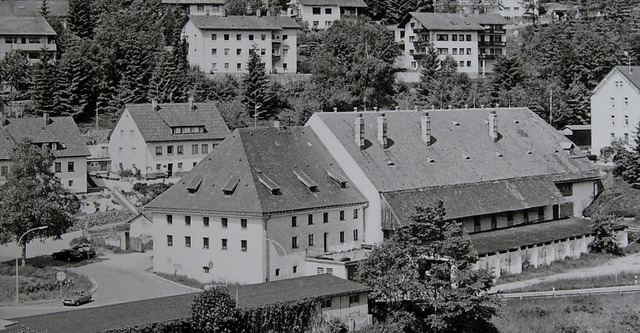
[0,15,57,62]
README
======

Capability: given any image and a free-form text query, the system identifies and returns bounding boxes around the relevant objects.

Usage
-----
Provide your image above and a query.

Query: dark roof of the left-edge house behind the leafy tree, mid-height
[0,117,90,160]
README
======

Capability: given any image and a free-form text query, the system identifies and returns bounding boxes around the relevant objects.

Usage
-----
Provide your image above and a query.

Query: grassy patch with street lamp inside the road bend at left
[0,256,96,303]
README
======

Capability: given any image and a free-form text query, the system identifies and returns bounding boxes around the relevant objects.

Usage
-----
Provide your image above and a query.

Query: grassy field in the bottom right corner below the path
[492,293,640,333]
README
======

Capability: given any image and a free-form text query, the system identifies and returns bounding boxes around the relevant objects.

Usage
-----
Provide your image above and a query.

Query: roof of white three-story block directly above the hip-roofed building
[189,15,281,30]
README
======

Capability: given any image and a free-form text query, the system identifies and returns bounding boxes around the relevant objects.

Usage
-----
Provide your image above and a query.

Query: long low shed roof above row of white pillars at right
[469,217,626,255]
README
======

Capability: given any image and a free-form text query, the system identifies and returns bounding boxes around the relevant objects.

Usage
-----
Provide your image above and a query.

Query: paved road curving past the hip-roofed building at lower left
[0,252,196,319]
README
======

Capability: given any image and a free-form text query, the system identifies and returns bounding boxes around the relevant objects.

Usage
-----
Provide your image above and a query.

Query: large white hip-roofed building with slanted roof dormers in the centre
[146,127,367,284]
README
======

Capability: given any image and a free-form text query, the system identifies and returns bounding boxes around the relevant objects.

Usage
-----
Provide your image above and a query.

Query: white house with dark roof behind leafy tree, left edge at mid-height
[0,112,89,193]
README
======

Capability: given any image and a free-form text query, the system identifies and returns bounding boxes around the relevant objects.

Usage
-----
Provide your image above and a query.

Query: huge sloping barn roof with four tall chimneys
[309,108,599,192]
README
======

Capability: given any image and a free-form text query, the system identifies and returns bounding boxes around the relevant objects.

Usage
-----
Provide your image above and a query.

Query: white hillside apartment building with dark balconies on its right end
[394,12,508,76]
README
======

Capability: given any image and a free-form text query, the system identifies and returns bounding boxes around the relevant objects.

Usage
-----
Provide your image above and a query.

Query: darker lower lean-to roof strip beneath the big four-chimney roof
[383,178,566,224]
